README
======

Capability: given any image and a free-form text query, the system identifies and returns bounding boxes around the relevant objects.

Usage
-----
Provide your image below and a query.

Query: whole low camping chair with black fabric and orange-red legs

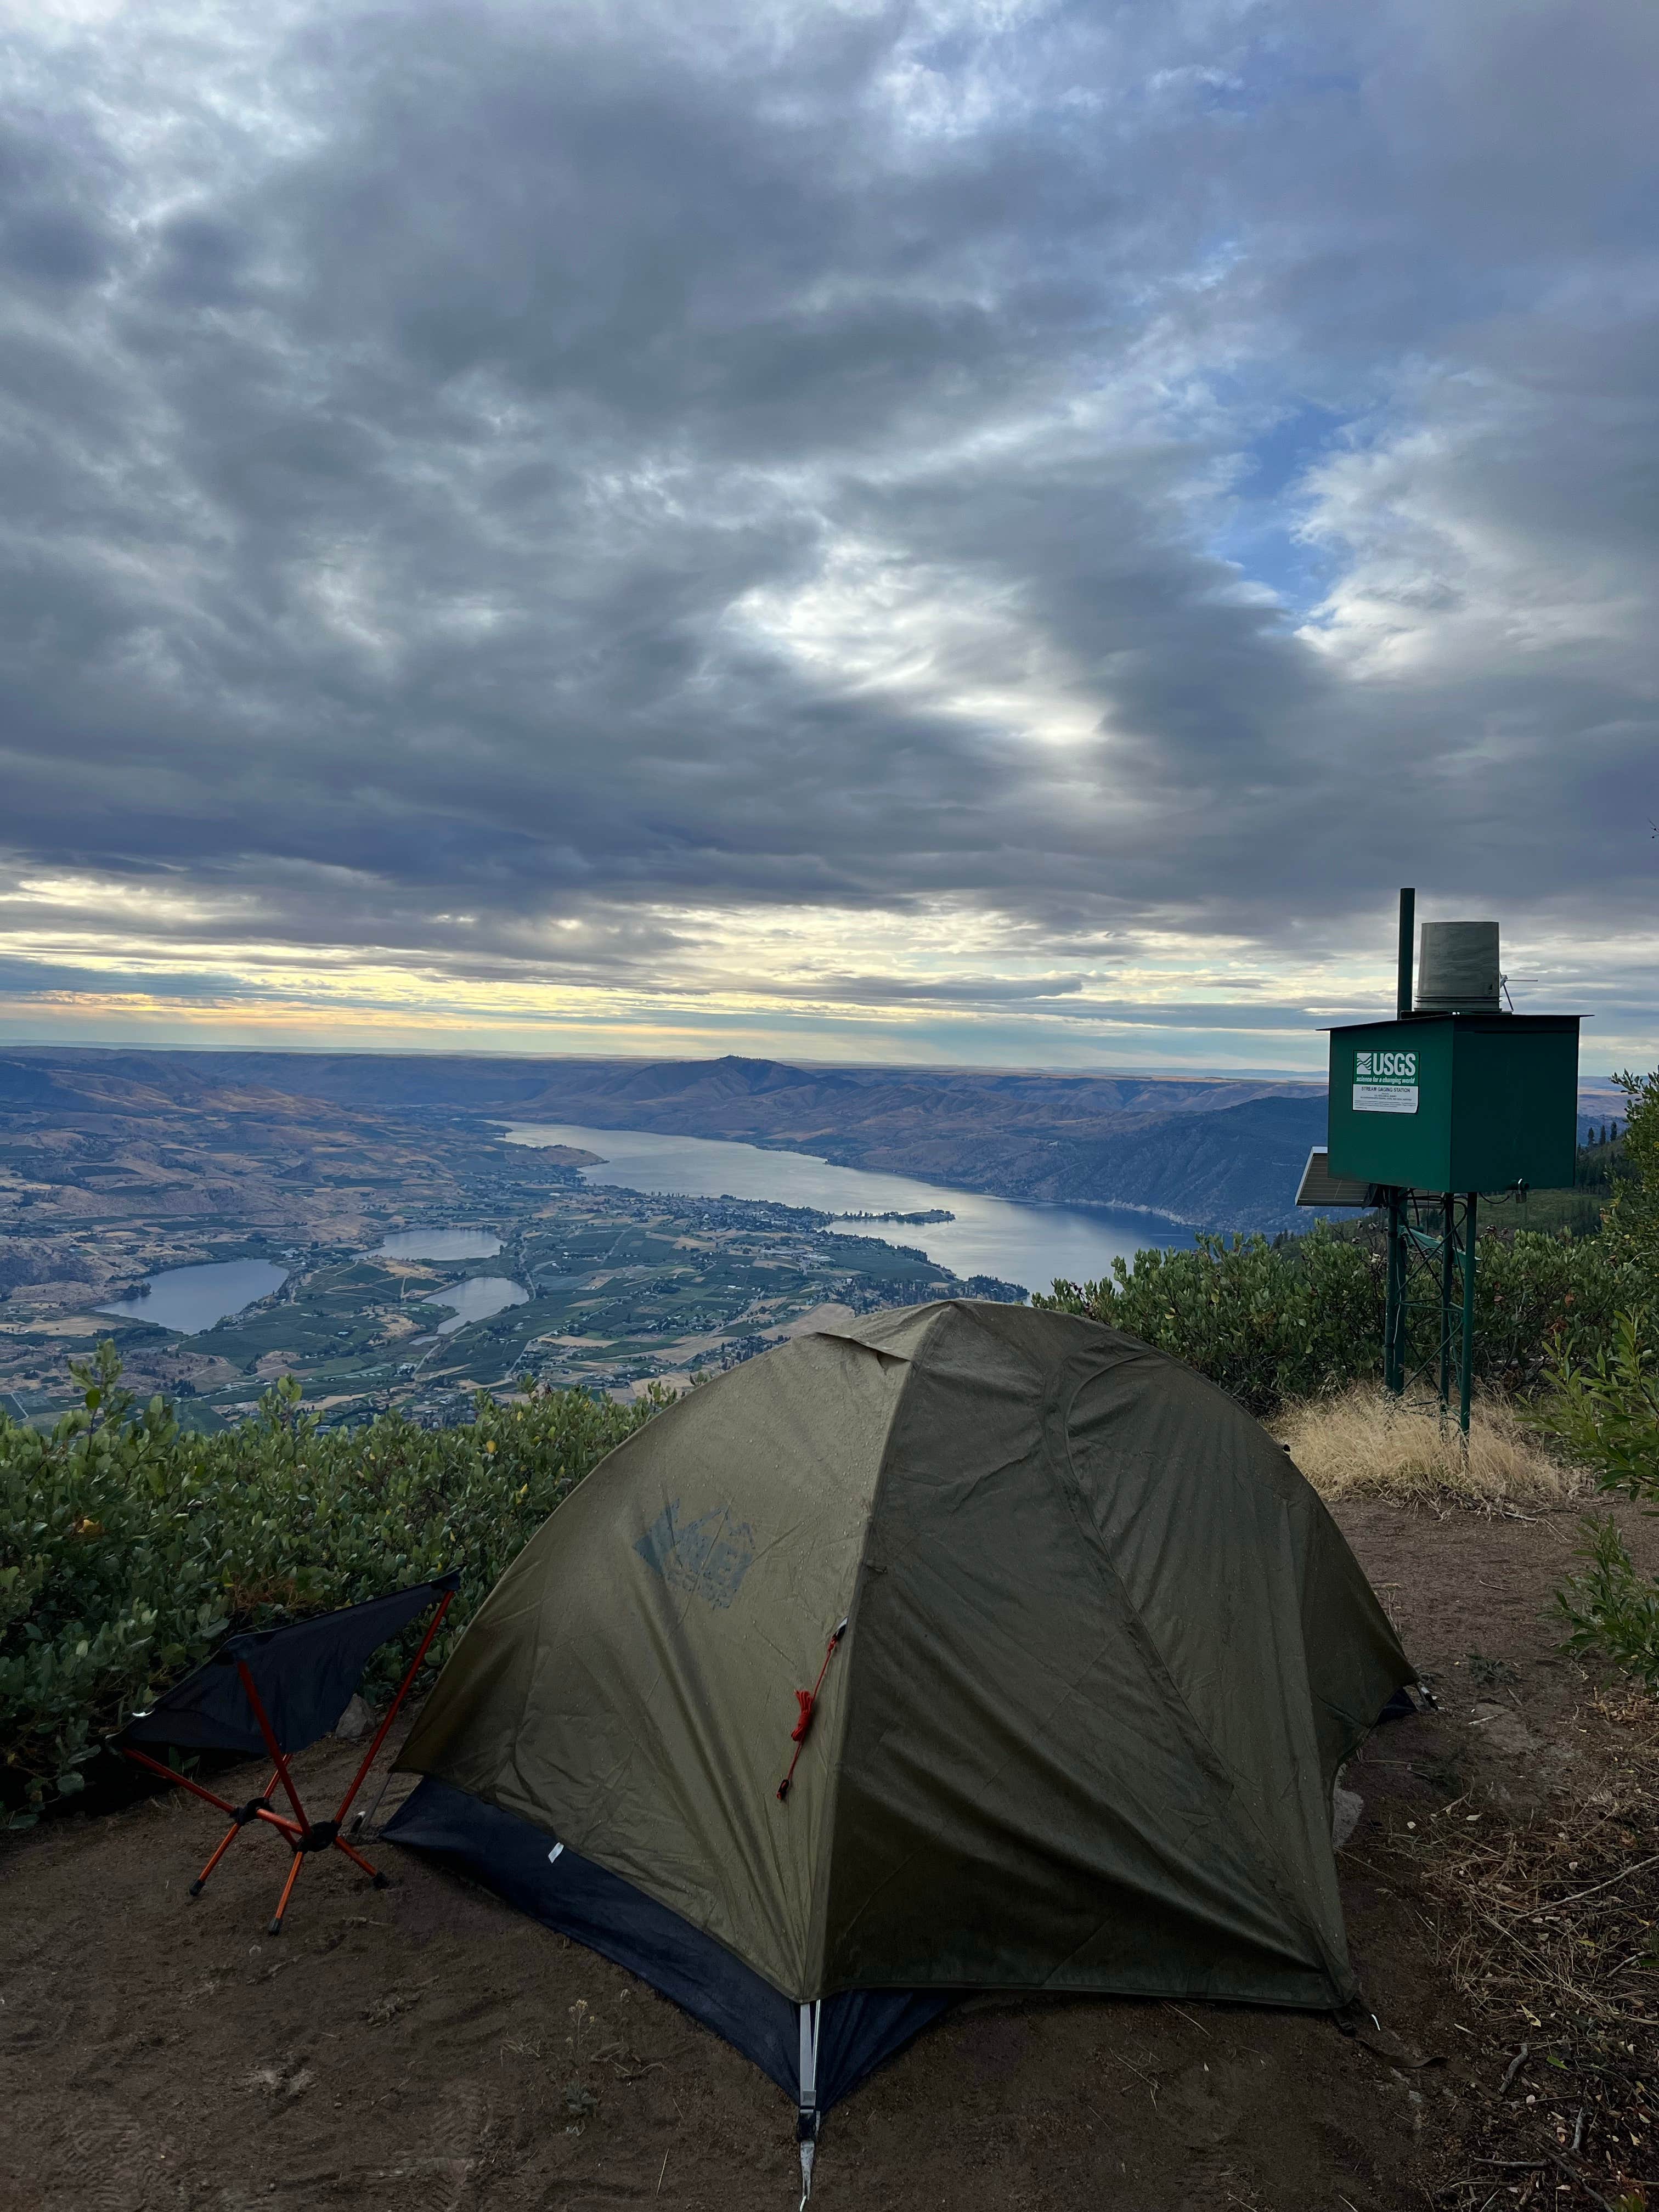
[109,1573,460,1936]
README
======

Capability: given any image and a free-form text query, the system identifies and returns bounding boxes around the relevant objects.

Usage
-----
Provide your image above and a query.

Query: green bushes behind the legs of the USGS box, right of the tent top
[1033,1223,1635,1413]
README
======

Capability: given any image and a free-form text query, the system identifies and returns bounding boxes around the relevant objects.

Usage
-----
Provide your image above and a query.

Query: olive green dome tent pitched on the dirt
[387,1301,1413,2172]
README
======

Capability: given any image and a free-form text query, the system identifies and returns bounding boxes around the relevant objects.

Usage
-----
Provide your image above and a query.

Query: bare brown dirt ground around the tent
[0,1504,1659,2212]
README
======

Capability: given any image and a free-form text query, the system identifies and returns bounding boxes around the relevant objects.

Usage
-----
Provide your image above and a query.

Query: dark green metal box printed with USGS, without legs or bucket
[1329,1013,1579,1192]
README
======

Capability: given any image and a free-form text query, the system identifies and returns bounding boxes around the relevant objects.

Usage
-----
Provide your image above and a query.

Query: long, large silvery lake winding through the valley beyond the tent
[504,1121,1192,1292]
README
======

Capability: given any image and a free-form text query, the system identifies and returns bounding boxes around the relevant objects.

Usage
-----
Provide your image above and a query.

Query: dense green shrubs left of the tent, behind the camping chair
[0,1342,659,1825]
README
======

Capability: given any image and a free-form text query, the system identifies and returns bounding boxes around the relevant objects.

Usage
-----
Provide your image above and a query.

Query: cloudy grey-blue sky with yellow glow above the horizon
[0,0,1659,1073]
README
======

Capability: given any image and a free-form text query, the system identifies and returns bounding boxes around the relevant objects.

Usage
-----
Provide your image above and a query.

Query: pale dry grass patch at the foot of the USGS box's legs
[1272,1383,1593,1513]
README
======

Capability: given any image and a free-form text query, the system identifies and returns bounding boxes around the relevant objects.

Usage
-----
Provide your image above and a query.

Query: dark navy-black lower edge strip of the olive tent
[383,1781,951,2113]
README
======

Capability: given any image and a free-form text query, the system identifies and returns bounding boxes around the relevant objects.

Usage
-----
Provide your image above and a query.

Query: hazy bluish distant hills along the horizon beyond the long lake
[0,1046,1325,1230]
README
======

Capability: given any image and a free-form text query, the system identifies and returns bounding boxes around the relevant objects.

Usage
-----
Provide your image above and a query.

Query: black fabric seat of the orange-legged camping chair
[111,1573,460,1758]
